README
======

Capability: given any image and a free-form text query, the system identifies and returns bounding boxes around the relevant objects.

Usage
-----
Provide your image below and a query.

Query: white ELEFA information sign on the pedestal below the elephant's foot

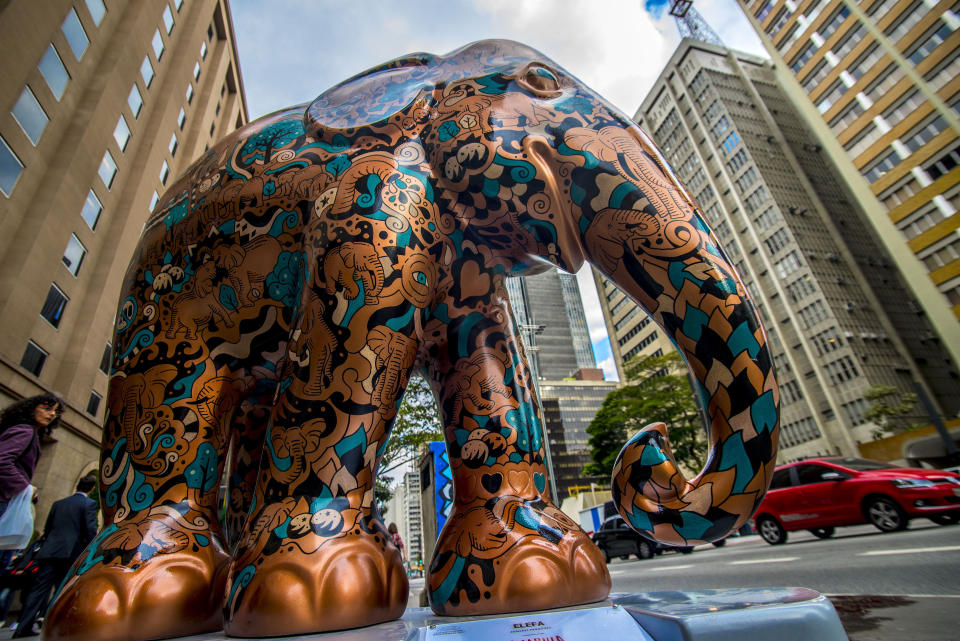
[416,605,654,641]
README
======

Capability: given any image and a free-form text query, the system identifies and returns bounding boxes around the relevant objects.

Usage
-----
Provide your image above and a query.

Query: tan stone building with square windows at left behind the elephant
[0,0,248,514]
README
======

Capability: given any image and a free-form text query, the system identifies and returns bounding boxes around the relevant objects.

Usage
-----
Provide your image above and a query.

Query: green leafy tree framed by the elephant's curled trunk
[584,352,706,476]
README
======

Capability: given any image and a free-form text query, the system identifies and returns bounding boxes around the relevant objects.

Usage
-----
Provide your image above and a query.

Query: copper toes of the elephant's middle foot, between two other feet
[224,529,409,638]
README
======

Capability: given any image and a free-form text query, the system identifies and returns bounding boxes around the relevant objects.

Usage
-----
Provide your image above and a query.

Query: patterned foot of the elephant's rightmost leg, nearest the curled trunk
[427,497,610,616]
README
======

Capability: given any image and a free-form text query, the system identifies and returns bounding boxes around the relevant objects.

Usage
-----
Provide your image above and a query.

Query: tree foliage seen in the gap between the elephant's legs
[374,374,443,513]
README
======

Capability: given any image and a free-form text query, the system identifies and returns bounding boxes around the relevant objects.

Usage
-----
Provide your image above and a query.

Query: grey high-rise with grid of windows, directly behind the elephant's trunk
[616,39,960,460]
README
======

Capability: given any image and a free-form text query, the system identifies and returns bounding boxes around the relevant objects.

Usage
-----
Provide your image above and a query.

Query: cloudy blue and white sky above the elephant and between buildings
[230,0,767,380]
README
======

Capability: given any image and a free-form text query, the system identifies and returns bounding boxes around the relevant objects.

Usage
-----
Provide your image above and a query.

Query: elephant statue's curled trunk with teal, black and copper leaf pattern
[567,127,780,545]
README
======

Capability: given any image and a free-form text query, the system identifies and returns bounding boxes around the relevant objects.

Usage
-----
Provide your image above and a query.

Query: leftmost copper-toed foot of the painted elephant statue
[43,545,229,641]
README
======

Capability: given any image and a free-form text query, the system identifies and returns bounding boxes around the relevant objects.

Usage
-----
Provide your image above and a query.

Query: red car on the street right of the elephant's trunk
[754,456,960,545]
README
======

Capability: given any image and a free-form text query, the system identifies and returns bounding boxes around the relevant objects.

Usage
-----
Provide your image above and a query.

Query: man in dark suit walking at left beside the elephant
[13,476,97,637]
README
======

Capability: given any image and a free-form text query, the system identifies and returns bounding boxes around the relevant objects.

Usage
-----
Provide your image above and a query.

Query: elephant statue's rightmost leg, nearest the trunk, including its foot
[427,300,610,616]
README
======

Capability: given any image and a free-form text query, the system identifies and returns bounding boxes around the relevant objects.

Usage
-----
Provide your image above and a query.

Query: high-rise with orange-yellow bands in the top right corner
[740,0,960,367]
